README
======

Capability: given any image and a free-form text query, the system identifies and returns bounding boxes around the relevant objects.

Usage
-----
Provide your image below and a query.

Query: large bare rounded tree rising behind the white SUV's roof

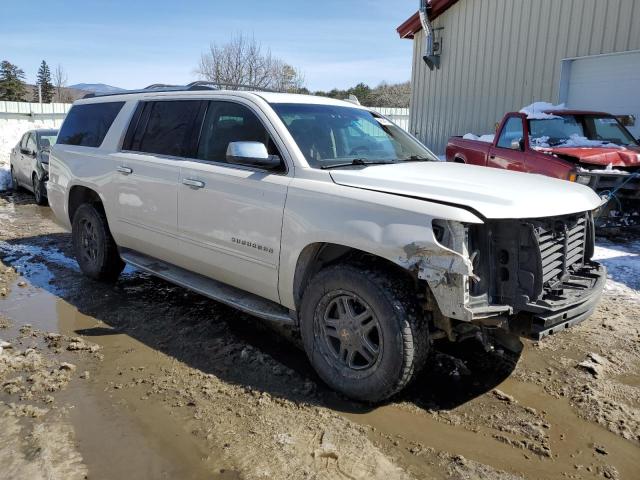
[196,34,304,92]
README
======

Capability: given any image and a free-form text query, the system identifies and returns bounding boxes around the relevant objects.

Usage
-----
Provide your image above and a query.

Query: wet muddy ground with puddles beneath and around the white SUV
[0,194,640,480]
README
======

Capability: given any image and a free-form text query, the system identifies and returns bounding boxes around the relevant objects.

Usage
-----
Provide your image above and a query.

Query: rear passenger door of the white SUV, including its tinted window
[114,100,203,263]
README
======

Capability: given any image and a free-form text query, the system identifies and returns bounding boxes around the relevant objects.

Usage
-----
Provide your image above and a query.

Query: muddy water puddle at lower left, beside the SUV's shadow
[2,279,239,479]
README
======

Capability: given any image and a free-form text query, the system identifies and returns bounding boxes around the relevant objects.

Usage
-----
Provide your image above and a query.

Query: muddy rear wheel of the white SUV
[72,203,125,282]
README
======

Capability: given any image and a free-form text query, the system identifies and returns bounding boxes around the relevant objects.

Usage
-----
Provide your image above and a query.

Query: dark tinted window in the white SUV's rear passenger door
[124,100,203,157]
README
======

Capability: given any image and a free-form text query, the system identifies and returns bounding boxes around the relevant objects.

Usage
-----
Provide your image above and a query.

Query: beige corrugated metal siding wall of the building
[410,0,640,153]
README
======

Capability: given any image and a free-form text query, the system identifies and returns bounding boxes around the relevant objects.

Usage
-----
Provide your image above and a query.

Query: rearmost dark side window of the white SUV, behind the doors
[57,102,124,147]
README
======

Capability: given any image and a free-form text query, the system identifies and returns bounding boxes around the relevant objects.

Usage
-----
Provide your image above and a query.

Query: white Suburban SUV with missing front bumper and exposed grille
[47,86,605,401]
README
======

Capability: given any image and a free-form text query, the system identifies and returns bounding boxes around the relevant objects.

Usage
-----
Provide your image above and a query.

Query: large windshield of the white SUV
[272,104,438,168]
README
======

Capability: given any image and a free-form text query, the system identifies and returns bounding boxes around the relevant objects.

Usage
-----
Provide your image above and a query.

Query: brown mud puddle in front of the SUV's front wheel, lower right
[344,379,640,479]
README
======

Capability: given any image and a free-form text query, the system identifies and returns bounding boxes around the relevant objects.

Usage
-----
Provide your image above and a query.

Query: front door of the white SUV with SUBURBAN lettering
[178,100,290,301]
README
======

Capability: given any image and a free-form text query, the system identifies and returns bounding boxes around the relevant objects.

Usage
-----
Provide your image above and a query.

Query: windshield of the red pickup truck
[529,115,638,147]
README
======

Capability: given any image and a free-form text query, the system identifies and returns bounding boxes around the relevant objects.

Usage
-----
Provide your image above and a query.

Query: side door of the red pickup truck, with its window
[487,115,527,172]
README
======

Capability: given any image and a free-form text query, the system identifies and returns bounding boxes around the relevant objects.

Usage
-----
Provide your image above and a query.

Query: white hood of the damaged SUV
[330,162,601,219]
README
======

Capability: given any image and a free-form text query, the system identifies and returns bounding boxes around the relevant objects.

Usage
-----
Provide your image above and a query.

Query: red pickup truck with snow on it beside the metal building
[446,109,640,228]
